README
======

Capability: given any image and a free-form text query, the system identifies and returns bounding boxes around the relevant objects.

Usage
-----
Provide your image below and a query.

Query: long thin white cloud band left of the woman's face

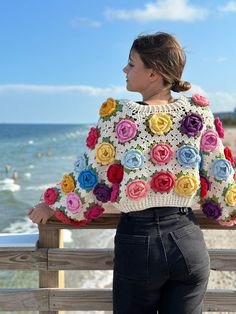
[0,84,126,97]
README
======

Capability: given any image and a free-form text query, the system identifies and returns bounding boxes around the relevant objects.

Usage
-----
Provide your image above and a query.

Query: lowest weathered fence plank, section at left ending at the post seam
[0,289,49,312]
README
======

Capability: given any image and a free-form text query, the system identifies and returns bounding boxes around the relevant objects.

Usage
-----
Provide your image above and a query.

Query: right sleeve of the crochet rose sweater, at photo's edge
[200,108,236,226]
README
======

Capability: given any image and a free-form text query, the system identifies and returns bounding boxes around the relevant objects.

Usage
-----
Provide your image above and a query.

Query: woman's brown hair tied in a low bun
[130,32,191,93]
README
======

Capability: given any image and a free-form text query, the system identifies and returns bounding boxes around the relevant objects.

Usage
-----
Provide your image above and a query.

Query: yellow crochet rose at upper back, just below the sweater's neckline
[149,113,172,135]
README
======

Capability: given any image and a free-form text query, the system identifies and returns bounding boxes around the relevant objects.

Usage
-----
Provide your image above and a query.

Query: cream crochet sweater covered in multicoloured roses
[43,94,236,226]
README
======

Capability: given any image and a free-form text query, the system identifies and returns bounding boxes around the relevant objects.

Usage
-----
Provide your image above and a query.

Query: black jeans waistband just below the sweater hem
[122,207,192,217]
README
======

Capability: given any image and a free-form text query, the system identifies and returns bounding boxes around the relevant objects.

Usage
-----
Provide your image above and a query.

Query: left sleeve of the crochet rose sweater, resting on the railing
[41,98,120,226]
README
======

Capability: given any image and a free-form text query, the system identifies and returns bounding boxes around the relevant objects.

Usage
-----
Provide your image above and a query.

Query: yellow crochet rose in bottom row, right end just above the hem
[174,175,198,196]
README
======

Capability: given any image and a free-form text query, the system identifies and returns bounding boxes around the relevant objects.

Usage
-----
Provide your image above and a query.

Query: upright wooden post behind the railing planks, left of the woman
[38,225,64,314]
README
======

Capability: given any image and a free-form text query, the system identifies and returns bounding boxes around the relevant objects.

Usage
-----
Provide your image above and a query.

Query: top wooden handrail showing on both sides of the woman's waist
[40,211,236,230]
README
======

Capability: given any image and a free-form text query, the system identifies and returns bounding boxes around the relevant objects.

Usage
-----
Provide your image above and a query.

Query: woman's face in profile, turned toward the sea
[123,50,153,94]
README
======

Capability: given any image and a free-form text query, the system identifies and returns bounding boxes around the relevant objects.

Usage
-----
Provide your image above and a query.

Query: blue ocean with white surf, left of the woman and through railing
[0,124,115,314]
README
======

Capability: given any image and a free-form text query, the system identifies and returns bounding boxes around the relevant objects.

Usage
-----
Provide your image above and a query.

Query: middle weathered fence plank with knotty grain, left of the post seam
[0,248,48,270]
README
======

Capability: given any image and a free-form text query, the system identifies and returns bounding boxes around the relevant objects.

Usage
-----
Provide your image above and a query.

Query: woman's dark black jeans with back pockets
[113,208,210,314]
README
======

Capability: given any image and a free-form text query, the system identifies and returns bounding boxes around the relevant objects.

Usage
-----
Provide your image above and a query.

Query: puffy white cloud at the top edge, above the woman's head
[105,0,208,22]
